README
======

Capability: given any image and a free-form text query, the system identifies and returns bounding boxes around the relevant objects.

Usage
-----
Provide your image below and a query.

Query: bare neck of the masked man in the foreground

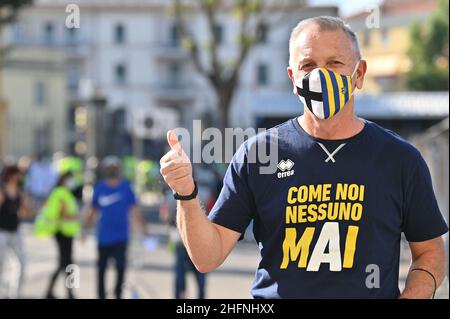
[297,105,364,140]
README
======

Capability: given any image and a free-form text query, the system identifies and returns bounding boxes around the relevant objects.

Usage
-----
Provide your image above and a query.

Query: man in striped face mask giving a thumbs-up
[161,17,448,298]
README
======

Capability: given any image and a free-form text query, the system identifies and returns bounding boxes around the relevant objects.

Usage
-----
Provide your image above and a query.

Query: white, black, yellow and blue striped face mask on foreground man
[295,61,359,120]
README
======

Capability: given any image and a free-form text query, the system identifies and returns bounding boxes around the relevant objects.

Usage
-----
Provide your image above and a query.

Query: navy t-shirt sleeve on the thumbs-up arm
[208,143,256,234]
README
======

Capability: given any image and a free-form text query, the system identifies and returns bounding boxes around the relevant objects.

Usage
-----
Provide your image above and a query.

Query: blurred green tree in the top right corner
[407,0,449,91]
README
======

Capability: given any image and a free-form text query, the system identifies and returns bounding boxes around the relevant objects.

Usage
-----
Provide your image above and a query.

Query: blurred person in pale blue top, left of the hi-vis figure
[25,154,58,210]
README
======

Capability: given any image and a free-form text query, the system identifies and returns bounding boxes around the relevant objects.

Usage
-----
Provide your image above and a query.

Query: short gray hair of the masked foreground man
[289,16,361,67]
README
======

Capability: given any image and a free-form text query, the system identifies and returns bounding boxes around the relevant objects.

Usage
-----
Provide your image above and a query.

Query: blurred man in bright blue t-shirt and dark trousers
[86,157,147,299]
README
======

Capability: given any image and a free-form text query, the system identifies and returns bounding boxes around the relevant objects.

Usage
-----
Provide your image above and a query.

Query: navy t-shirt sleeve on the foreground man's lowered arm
[402,152,448,242]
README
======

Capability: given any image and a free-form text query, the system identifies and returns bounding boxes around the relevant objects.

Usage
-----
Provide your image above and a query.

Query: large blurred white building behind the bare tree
[6,0,337,159]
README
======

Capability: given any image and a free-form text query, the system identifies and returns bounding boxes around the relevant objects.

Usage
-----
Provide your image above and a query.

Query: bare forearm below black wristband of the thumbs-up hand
[177,198,222,272]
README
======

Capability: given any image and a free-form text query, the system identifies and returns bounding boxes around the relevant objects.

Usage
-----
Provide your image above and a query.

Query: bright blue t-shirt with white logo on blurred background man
[92,181,136,246]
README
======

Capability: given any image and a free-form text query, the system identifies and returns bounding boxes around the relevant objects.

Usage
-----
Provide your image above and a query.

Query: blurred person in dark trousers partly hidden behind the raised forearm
[160,188,206,299]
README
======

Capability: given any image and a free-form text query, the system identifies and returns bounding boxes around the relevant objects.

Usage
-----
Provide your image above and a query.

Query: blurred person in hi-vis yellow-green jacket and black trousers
[41,172,81,299]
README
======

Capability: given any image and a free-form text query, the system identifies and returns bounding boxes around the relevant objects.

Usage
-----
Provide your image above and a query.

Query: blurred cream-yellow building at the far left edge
[0,47,68,160]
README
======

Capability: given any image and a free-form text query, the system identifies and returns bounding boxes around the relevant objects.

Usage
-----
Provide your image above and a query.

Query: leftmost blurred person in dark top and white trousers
[0,165,32,298]
